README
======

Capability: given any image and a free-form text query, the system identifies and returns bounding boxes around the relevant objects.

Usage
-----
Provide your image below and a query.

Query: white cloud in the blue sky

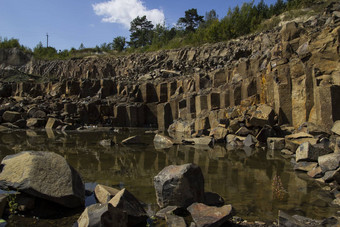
[92,0,165,28]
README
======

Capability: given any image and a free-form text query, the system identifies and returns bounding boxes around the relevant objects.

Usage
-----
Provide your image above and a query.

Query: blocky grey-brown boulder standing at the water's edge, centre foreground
[154,164,204,208]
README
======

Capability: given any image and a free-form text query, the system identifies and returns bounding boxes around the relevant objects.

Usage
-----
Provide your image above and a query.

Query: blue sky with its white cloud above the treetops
[0,0,276,50]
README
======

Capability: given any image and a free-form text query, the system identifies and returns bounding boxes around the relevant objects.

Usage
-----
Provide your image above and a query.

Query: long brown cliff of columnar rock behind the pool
[0,3,340,133]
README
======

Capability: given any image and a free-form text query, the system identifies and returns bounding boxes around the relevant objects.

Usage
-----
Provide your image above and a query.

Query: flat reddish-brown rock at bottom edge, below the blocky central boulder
[188,203,232,227]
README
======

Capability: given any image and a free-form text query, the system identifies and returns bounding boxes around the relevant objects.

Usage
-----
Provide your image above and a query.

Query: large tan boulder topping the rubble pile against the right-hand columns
[249,104,275,127]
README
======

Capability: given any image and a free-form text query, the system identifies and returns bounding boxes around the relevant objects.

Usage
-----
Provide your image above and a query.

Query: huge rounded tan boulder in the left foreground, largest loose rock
[0,151,85,208]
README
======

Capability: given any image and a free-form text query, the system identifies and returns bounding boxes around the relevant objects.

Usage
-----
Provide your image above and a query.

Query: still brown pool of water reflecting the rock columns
[0,127,336,224]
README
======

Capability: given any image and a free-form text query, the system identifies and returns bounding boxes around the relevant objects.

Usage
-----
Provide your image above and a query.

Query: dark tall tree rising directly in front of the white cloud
[129,16,153,48]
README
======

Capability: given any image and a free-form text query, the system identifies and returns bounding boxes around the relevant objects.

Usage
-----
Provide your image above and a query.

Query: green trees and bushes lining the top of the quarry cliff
[0,0,317,59]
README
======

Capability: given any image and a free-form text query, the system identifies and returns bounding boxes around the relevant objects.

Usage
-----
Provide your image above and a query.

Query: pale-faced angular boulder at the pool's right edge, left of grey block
[295,142,329,162]
